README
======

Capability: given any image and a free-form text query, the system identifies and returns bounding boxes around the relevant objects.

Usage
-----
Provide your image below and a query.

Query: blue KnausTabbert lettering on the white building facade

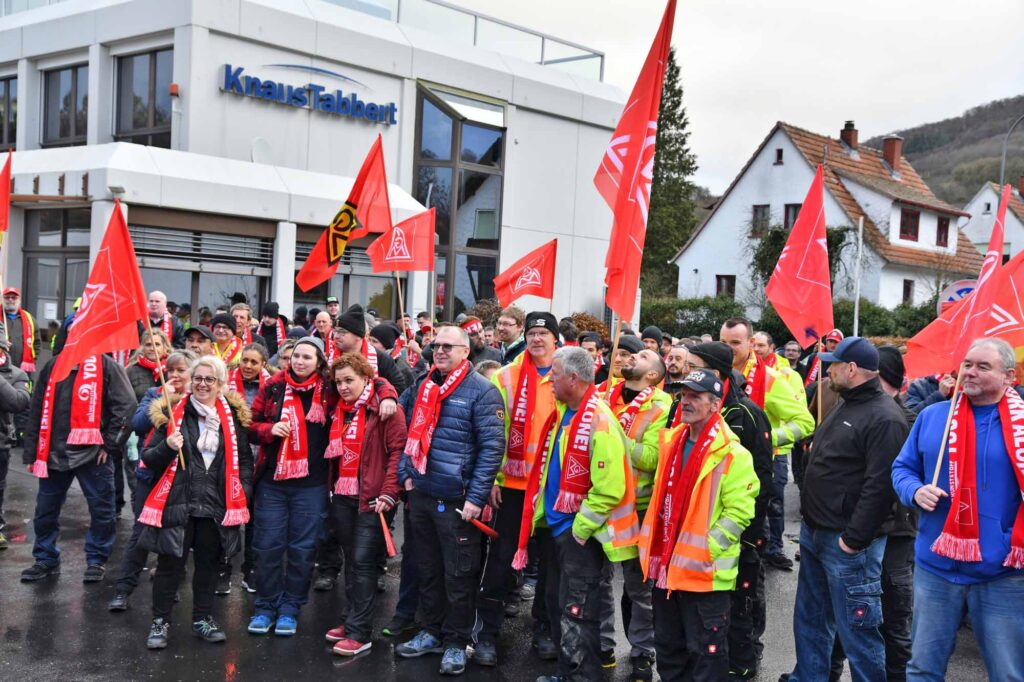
[220,63,398,125]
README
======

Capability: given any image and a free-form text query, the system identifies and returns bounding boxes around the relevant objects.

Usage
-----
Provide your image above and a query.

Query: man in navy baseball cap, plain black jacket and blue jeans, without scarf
[790,336,909,682]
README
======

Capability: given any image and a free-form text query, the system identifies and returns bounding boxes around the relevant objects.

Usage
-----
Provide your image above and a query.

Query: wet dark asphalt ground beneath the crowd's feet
[0,452,985,682]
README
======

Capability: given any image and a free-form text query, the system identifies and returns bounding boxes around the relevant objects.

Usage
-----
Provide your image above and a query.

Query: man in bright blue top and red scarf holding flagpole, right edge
[893,339,1024,681]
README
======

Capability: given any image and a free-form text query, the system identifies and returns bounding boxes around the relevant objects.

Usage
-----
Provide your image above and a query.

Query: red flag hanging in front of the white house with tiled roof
[765,164,834,348]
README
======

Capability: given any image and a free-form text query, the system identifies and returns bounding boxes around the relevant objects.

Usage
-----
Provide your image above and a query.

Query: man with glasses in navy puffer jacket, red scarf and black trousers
[395,325,505,675]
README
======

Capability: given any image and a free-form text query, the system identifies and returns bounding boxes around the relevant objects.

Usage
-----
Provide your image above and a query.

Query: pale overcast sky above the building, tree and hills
[455,0,1024,194]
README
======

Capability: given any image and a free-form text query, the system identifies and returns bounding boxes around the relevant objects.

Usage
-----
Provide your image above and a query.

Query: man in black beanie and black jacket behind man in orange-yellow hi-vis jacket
[686,341,774,680]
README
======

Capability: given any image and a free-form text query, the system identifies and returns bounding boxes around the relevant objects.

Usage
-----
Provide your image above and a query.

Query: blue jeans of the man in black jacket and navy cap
[790,523,886,682]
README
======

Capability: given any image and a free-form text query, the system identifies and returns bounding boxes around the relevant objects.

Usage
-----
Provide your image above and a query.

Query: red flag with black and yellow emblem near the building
[295,133,391,291]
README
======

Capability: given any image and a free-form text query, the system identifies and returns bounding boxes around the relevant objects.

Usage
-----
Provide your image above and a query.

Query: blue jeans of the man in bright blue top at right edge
[906,565,1024,682]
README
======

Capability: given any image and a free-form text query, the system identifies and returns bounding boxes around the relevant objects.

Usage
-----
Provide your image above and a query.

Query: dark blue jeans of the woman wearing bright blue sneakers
[253,480,328,617]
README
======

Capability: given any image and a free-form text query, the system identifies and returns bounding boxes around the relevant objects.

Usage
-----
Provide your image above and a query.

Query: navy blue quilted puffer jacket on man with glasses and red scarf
[398,372,505,507]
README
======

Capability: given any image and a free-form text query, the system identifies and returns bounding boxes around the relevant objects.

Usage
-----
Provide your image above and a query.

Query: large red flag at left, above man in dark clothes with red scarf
[51,200,148,381]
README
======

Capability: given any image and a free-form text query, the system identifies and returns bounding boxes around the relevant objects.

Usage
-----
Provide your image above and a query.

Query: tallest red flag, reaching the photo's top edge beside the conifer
[594,0,676,319]
